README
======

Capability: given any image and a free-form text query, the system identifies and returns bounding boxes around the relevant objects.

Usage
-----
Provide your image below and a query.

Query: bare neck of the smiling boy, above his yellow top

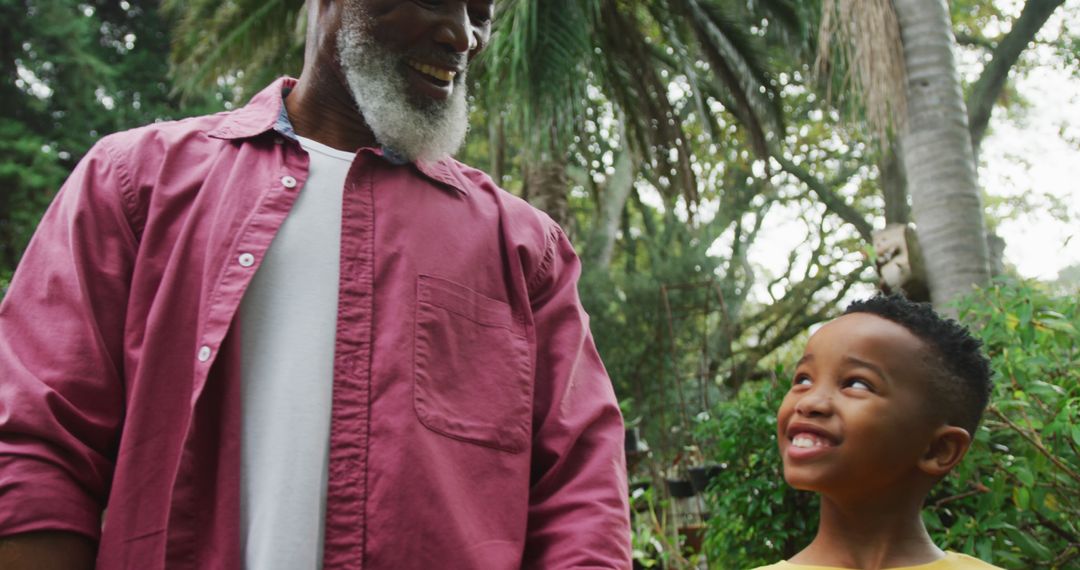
[791,494,945,570]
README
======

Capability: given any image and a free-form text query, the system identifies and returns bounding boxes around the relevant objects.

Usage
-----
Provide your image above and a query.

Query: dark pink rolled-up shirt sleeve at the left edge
[0,137,136,540]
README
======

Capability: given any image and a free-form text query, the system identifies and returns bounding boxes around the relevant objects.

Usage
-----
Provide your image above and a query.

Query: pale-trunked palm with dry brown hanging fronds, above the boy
[819,0,990,311]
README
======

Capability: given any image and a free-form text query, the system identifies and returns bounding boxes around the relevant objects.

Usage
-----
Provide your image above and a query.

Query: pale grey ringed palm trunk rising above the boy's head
[893,0,989,313]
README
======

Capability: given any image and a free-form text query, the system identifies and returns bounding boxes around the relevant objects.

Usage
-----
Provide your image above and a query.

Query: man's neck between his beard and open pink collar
[285,69,378,152]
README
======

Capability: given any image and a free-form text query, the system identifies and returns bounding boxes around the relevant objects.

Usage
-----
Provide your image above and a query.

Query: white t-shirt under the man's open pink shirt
[240,137,355,570]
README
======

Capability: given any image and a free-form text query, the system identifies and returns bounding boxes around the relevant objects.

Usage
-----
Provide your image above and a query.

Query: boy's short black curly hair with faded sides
[843,295,991,437]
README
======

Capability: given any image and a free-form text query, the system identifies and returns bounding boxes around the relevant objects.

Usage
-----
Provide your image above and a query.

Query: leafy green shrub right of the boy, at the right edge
[924,281,1080,568]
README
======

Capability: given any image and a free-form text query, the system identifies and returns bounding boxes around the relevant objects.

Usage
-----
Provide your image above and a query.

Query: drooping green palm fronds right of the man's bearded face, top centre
[482,0,807,253]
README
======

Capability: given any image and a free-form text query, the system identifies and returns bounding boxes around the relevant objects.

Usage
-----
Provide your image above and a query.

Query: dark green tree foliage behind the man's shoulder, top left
[0,0,219,284]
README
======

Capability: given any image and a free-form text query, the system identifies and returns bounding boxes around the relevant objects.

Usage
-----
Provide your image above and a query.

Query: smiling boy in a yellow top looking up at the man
[764,296,996,570]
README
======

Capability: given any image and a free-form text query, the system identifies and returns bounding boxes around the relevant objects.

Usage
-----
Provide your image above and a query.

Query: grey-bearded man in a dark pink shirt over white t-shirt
[0,0,630,570]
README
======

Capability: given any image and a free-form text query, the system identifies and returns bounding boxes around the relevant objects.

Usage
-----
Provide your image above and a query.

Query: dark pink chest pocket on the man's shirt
[413,275,532,453]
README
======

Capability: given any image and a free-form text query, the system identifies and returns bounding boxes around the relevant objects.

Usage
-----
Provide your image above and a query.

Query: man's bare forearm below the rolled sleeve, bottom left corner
[0,532,96,570]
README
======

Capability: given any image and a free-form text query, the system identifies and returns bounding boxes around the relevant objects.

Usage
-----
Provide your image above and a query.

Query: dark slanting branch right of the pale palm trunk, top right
[968,0,1065,154]
